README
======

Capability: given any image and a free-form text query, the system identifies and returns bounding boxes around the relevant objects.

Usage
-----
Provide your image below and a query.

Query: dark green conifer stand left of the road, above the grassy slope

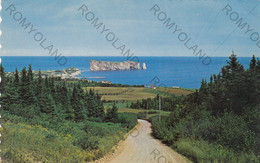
[0,65,105,122]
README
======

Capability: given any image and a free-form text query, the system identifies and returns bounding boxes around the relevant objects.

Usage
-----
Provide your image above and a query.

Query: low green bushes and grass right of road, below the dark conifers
[152,108,259,162]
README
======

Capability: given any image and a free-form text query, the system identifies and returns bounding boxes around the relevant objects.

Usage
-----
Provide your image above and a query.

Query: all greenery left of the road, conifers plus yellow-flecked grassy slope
[0,65,137,162]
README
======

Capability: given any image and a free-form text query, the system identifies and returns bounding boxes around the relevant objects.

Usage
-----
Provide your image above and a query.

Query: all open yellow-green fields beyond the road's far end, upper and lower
[87,87,194,119]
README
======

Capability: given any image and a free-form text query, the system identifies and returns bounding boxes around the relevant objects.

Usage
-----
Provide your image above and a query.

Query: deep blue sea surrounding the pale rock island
[1,57,251,88]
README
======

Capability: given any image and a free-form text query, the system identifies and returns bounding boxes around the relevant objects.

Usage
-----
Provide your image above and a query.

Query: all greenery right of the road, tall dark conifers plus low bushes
[150,54,260,162]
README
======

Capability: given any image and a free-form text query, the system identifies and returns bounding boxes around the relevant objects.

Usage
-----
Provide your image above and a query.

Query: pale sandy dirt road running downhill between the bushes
[92,120,189,163]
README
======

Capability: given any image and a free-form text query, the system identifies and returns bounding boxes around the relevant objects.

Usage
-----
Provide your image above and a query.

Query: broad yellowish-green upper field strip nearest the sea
[84,87,193,101]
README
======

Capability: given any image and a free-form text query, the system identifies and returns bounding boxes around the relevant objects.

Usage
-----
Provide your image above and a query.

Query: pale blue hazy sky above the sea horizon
[0,0,260,57]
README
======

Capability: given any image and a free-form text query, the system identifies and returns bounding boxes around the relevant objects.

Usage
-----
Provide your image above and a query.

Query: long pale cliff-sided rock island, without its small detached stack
[90,60,141,71]
